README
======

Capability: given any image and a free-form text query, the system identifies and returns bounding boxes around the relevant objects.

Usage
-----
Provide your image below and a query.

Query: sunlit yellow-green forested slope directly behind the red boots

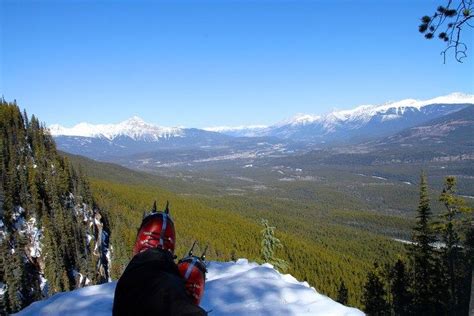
[64,152,404,307]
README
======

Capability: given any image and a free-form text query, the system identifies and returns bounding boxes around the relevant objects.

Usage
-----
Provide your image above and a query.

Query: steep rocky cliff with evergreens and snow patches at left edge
[0,99,110,314]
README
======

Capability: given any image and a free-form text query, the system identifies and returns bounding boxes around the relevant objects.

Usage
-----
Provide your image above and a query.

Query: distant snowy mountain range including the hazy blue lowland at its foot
[50,93,474,163]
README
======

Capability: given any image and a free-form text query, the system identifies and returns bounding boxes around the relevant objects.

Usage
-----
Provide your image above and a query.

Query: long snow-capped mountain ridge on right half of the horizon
[207,92,474,141]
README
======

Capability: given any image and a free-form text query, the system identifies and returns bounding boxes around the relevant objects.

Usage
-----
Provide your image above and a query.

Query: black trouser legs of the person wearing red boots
[113,249,207,316]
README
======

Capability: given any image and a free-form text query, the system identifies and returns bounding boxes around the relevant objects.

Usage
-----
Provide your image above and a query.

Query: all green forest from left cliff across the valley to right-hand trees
[0,100,472,315]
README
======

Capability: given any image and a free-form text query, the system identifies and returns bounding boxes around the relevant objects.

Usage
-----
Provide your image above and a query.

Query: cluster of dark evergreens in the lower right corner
[362,173,474,315]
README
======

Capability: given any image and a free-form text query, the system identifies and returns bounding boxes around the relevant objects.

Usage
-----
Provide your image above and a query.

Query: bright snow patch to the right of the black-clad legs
[202,259,363,315]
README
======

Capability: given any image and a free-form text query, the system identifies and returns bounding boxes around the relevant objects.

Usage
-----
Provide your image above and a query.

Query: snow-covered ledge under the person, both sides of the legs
[17,259,364,316]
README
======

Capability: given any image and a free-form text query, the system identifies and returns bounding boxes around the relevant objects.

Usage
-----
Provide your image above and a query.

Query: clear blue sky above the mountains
[0,0,474,127]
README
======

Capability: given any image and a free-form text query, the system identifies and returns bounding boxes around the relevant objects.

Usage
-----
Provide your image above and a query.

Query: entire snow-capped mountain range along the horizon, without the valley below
[49,93,474,142]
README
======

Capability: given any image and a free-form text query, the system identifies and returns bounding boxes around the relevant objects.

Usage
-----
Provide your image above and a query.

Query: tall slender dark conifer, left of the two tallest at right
[409,172,436,315]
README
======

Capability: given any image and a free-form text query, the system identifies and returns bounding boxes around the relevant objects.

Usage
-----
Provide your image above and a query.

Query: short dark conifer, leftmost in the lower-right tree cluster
[362,263,390,316]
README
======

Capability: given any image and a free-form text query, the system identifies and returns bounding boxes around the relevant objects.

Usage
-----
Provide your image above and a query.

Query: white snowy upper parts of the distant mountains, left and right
[49,92,474,141]
